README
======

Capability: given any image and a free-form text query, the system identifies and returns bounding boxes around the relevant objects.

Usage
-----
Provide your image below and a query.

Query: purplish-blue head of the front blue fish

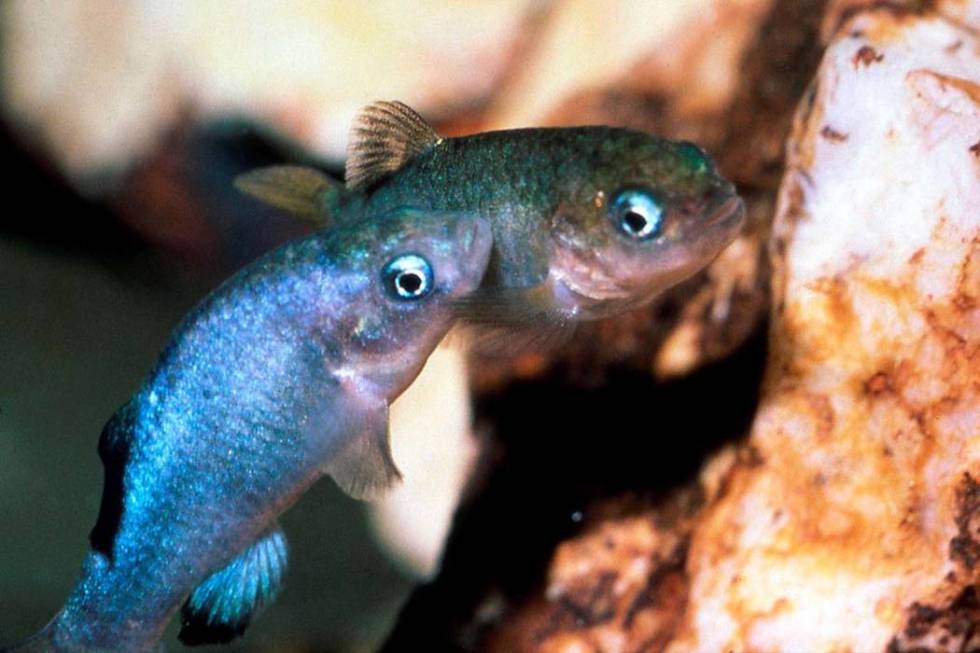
[334,209,493,400]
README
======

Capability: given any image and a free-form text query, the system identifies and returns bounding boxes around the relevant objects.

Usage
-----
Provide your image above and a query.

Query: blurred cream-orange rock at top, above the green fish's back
[486,0,771,129]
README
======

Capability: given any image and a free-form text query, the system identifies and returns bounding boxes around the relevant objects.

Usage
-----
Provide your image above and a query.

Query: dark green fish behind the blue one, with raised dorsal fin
[236,102,745,330]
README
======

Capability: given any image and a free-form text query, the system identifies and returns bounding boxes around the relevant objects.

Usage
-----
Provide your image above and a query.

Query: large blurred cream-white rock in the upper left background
[0,0,537,188]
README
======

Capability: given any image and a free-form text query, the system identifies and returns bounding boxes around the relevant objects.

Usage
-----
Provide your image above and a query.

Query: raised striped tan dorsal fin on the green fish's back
[346,102,442,191]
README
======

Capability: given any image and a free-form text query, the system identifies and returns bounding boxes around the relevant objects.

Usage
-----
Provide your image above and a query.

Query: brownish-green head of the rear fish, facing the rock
[551,129,745,318]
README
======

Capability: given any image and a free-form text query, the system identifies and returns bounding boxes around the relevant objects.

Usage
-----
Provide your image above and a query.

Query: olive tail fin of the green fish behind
[235,165,343,226]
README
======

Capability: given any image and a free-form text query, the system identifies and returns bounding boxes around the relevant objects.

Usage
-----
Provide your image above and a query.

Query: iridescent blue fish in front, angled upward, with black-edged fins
[9,212,491,652]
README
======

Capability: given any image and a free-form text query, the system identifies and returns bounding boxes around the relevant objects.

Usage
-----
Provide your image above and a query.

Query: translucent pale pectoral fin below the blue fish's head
[325,402,402,499]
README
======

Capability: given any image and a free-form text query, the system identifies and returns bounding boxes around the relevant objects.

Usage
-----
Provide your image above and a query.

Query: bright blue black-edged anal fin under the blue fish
[178,526,288,646]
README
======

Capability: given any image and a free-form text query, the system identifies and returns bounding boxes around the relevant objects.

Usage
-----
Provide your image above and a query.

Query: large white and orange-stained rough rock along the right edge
[669,10,980,651]
